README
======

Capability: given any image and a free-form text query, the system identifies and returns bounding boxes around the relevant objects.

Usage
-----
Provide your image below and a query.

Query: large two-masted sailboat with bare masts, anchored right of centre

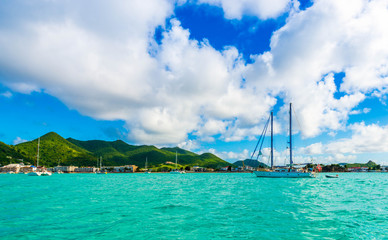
[253,103,316,178]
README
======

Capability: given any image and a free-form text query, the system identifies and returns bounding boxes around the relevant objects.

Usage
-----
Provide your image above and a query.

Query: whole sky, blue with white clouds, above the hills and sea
[0,0,388,164]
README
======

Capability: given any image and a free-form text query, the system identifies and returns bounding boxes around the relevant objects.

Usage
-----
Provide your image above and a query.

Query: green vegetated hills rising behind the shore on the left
[0,132,230,170]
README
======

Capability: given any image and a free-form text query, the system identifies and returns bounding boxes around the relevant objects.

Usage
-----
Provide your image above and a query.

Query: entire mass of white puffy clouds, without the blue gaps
[0,0,388,151]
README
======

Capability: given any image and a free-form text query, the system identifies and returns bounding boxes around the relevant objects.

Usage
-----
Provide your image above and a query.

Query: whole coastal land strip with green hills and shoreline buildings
[0,132,387,173]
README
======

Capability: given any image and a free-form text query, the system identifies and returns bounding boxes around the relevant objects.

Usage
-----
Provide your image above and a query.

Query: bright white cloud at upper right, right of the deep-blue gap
[246,0,388,137]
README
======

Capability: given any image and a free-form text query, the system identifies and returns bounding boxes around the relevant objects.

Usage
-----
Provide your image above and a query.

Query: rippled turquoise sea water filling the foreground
[0,173,388,239]
